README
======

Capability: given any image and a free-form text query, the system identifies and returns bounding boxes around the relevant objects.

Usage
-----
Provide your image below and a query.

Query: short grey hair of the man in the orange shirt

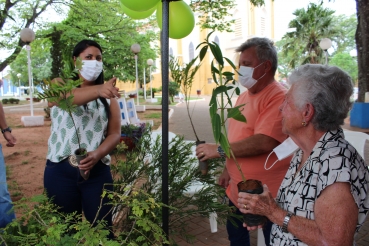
[236,38,278,75]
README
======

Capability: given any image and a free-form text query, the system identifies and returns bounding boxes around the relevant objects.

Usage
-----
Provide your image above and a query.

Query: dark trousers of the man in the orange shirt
[227,200,273,246]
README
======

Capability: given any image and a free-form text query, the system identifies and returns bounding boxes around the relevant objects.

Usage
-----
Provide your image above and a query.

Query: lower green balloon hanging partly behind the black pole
[156,1,195,39]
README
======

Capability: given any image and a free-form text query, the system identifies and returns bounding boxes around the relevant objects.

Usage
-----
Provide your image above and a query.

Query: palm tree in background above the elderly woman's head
[282,3,338,68]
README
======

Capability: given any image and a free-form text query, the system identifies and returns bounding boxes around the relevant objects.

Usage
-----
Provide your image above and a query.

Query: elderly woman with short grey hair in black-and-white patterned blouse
[238,64,369,245]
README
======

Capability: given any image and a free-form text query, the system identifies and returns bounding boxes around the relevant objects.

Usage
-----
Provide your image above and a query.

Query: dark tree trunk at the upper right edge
[355,0,369,102]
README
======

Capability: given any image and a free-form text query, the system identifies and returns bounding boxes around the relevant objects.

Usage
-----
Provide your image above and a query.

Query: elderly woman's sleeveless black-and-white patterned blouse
[271,129,369,245]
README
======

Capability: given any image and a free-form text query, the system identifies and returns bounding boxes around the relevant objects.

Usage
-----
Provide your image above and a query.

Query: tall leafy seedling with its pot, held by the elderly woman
[197,33,266,226]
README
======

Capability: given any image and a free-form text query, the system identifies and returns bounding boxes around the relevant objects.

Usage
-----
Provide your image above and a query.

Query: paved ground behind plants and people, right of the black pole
[169,97,369,246]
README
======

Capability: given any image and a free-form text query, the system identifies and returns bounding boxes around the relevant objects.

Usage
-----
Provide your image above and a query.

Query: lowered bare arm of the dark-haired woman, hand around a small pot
[79,98,120,170]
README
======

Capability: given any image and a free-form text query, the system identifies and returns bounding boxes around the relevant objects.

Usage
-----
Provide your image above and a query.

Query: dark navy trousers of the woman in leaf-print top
[44,159,113,233]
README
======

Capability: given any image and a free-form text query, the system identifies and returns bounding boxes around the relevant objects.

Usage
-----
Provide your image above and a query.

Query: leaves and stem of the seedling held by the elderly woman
[196,32,246,181]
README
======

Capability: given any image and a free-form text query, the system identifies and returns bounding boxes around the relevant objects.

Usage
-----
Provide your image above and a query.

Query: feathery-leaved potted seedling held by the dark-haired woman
[38,59,90,180]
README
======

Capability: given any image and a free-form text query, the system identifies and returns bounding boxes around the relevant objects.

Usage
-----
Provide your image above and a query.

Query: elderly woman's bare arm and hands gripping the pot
[239,182,358,245]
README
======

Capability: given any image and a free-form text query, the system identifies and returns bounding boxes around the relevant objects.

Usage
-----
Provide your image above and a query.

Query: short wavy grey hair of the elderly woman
[288,64,353,131]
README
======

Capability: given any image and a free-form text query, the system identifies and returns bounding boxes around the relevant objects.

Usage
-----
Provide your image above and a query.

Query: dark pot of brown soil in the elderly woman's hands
[237,179,267,226]
